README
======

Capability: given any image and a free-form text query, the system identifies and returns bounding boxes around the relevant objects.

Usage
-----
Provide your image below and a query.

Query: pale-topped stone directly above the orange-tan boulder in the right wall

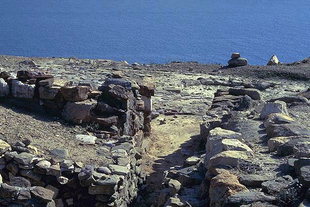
[208,151,252,169]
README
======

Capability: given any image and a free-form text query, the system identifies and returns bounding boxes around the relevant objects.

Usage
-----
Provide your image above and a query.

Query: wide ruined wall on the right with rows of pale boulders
[201,88,310,207]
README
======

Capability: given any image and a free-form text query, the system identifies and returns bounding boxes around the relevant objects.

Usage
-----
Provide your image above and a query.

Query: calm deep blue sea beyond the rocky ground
[0,0,310,64]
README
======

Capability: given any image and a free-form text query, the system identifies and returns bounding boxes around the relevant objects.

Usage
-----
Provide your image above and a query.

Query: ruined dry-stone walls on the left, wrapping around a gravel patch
[0,71,154,207]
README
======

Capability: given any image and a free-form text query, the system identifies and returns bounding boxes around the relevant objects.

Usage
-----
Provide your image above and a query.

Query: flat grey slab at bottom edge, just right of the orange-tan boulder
[225,191,276,207]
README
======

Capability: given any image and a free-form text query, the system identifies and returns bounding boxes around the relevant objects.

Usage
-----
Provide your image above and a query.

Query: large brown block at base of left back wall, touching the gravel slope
[62,100,96,124]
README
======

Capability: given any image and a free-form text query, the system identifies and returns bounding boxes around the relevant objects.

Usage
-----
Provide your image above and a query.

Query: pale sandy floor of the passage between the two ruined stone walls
[145,115,201,189]
